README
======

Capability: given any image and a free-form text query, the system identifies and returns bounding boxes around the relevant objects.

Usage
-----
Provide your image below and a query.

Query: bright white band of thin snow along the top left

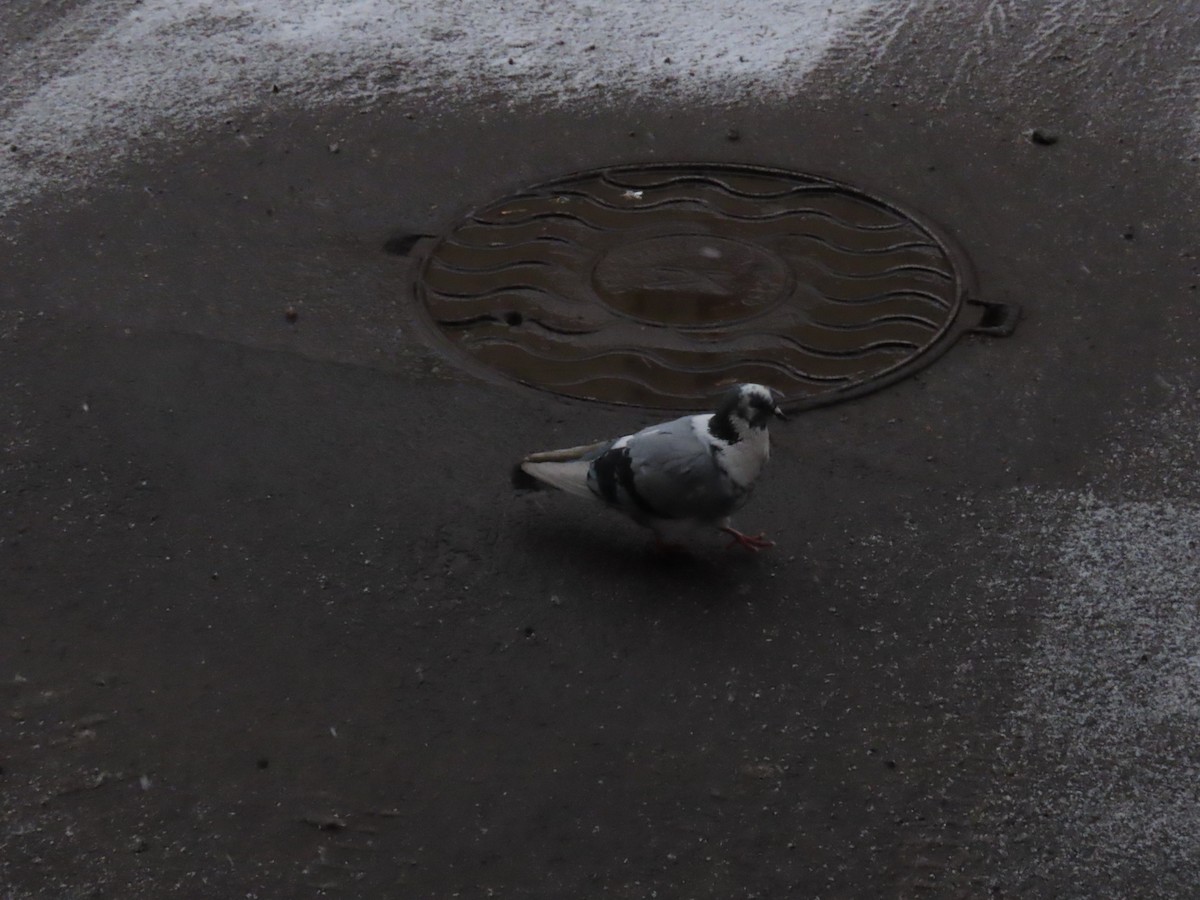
[0,0,880,210]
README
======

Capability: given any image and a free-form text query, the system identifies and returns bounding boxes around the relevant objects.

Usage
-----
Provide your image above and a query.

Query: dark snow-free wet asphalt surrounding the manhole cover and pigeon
[0,3,1200,898]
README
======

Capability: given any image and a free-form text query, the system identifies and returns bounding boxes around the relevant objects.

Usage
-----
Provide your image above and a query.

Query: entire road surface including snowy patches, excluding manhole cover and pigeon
[0,0,1200,900]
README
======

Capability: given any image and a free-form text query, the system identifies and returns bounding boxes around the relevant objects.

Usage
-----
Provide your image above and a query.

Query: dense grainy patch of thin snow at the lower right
[1016,499,1200,886]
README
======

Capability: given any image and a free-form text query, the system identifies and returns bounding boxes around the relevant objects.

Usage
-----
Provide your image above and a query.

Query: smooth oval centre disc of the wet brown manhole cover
[592,234,787,328]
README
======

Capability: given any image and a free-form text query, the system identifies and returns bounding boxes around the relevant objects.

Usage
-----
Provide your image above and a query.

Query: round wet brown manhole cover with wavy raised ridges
[418,166,1015,409]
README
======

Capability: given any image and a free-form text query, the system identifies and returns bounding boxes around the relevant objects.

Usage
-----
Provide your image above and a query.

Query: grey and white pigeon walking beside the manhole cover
[514,384,787,552]
